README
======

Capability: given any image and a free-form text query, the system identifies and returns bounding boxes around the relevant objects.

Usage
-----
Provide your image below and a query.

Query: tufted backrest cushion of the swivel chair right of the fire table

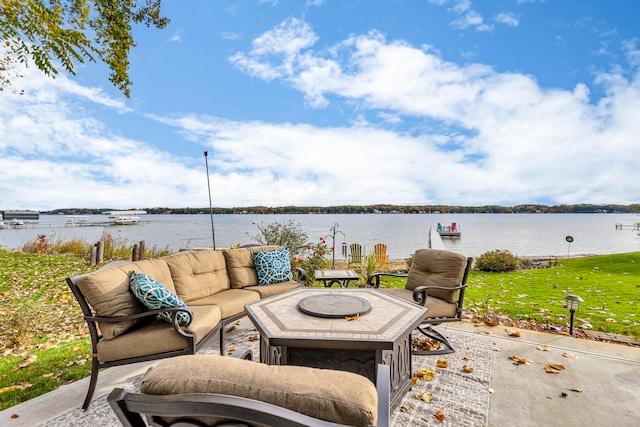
[405,249,467,303]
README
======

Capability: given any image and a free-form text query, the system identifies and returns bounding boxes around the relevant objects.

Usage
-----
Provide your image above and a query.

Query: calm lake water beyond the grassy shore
[0,214,640,259]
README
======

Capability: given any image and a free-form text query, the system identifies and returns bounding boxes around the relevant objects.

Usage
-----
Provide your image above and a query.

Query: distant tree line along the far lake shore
[42,204,640,215]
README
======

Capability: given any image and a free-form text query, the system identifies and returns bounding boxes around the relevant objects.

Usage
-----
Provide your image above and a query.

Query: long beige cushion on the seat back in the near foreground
[140,355,378,426]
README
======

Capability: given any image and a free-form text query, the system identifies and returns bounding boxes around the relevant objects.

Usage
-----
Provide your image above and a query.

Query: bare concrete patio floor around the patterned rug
[0,319,640,427]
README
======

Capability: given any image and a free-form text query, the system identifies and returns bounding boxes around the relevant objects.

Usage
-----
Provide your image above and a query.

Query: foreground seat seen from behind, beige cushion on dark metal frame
[107,354,390,427]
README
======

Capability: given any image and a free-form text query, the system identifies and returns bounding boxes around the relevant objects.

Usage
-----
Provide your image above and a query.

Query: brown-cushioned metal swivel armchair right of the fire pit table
[367,249,473,354]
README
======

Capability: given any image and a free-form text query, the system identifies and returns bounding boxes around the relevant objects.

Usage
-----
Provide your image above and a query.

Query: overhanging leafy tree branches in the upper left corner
[0,0,169,97]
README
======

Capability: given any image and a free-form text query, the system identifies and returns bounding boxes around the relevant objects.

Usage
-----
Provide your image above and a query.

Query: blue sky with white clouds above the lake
[0,0,640,210]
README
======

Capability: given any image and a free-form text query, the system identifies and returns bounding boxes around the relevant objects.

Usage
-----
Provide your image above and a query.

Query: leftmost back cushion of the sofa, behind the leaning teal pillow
[77,259,175,340]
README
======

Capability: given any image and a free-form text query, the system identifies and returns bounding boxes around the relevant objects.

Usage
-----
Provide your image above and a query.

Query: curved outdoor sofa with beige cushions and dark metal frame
[66,246,306,409]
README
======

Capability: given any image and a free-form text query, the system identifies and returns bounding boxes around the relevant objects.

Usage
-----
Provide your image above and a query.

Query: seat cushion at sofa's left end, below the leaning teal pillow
[97,306,222,362]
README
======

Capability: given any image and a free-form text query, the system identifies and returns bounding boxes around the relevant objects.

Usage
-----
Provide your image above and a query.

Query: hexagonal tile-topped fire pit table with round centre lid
[245,289,427,407]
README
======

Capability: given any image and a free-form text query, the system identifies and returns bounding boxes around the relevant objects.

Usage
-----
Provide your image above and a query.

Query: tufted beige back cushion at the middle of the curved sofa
[162,249,229,303]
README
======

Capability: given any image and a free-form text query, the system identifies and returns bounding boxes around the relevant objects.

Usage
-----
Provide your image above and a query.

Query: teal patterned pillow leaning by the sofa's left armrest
[129,271,191,326]
